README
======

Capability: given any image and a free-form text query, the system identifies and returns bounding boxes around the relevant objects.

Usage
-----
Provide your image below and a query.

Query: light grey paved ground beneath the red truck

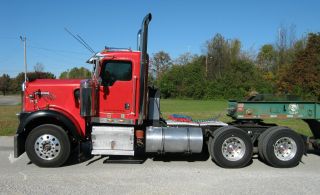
[0,137,320,194]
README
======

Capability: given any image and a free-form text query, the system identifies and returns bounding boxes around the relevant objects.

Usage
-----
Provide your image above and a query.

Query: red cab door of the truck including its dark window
[99,60,134,118]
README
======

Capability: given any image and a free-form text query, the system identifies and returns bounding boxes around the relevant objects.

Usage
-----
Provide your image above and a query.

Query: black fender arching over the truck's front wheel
[14,110,85,158]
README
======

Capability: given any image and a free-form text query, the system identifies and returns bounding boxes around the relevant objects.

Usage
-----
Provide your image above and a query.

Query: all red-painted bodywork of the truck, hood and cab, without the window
[23,50,140,136]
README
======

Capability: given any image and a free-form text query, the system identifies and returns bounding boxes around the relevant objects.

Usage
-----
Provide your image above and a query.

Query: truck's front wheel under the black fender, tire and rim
[25,124,70,167]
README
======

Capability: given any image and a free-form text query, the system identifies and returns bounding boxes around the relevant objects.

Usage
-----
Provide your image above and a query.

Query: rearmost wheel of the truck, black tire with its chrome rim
[262,127,304,168]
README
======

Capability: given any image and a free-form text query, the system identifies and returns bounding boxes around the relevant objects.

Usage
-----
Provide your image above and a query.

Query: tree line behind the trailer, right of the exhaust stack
[150,30,320,101]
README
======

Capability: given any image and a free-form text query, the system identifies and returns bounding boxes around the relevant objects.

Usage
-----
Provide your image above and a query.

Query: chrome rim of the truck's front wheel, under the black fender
[34,134,61,160]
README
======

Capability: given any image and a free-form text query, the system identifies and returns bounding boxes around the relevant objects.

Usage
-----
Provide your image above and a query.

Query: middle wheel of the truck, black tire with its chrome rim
[209,126,253,168]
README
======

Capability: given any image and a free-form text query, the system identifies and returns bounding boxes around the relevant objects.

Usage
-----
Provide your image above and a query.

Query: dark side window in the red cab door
[100,61,132,86]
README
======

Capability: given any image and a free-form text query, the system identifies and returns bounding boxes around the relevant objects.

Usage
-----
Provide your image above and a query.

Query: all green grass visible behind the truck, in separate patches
[0,99,311,136]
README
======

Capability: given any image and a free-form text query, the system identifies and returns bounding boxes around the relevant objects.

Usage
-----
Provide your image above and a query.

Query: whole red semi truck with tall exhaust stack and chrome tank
[14,14,304,168]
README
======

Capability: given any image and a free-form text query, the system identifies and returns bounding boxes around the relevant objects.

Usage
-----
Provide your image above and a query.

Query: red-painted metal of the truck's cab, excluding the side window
[99,51,140,122]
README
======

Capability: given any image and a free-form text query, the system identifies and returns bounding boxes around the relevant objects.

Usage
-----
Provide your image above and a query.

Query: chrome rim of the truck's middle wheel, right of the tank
[221,137,246,161]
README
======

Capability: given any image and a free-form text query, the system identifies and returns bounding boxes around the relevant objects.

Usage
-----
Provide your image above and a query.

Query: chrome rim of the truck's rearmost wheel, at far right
[273,137,297,161]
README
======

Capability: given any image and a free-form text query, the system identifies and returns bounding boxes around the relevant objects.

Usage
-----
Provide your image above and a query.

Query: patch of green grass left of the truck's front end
[0,105,21,136]
